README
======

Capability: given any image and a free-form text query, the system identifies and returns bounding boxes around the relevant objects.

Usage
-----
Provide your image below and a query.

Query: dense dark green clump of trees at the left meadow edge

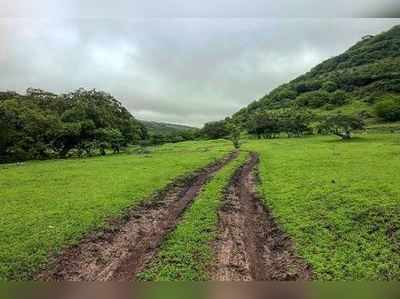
[0,89,147,162]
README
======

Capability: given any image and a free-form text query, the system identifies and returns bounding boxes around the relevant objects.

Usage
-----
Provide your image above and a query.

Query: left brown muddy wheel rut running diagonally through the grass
[35,153,237,281]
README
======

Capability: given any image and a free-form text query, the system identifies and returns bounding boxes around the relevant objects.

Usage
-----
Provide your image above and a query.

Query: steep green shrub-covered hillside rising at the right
[232,25,400,125]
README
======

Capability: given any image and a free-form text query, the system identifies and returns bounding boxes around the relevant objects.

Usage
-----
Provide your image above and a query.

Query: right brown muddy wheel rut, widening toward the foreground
[211,154,311,281]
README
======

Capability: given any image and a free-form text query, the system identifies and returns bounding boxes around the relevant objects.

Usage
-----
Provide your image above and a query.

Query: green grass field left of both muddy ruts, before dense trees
[0,141,233,280]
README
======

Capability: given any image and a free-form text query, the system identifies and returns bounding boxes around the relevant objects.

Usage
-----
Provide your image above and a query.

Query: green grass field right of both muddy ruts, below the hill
[245,134,400,280]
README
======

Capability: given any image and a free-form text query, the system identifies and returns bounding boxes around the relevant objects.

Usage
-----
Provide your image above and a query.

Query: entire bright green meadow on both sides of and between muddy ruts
[0,133,400,280]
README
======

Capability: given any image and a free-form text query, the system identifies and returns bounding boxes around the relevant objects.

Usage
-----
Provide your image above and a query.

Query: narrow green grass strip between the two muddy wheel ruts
[139,152,248,281]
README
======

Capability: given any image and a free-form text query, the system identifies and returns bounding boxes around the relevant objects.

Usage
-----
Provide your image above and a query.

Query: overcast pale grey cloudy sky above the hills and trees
[0,0,400,126]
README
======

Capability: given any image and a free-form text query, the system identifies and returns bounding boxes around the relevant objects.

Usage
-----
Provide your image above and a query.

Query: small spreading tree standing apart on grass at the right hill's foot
[318,113,364,140]
